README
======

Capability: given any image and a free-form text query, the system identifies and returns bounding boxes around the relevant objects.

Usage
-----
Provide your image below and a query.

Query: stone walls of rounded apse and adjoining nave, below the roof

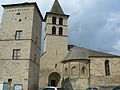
[63,57,120,90]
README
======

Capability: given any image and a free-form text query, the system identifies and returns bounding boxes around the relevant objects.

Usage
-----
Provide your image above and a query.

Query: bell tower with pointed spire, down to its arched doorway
[39,0,69,87]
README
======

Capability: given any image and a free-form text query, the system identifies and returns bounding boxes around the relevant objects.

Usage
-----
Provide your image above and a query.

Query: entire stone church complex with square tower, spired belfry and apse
[0,0,120,90]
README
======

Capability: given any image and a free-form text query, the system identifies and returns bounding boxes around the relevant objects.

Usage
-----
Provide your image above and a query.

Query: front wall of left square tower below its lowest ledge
[0,60,29,90]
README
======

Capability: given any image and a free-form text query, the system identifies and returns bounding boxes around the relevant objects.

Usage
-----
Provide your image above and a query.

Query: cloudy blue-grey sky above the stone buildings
[0,0,120,55]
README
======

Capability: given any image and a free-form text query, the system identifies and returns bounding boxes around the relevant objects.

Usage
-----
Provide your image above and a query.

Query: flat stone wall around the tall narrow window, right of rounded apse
[90,57,120,87]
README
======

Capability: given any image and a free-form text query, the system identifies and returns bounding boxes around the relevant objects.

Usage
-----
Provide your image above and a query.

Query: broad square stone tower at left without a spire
[0,3,42,90]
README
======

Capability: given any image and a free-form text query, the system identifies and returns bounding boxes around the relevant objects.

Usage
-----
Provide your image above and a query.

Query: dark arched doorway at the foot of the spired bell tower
[48,72,61,87]
